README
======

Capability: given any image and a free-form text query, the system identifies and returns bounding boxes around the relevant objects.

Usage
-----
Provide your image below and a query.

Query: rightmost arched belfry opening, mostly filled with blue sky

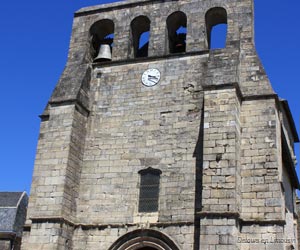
[205,7,227,49]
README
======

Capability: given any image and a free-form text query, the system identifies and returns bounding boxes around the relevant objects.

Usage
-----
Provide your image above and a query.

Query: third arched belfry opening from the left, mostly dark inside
[167,11,187,53]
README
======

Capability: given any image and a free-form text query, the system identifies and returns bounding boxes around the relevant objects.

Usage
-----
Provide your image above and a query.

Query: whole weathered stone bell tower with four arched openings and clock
[22,0,299,250]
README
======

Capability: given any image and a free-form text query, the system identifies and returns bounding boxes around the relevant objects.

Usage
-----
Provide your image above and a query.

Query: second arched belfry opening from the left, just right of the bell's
[131,16,150,57]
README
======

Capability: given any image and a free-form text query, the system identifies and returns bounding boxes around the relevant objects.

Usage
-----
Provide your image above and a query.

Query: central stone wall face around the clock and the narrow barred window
[77,56,207,224]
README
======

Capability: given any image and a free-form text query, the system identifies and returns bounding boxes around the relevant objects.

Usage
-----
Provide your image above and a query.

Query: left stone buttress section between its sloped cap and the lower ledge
[27,105,85,219]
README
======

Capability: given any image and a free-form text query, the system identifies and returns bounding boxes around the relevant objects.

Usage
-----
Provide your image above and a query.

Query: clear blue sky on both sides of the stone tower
[0,0,300,193]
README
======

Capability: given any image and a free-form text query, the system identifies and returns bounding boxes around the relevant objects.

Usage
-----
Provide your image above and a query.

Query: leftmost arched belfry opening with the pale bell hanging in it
[90,19,114,61]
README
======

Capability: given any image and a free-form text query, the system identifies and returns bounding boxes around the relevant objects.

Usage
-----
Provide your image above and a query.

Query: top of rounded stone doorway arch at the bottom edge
[109,229,179,250]
